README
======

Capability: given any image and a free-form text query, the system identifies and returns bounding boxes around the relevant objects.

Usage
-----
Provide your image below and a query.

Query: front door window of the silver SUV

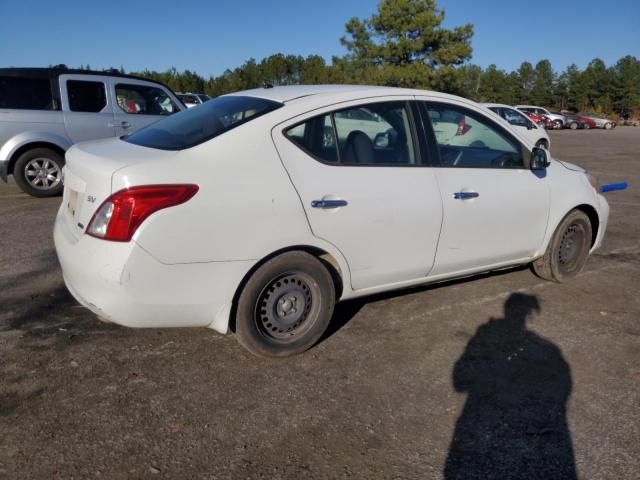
[116,83,180,115]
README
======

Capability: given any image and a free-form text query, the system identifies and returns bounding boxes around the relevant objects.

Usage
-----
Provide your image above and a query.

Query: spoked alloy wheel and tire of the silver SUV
[13,148,64,197]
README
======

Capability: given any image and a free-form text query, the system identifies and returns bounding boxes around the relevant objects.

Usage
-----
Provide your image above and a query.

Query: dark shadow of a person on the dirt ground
[444,293,577,480]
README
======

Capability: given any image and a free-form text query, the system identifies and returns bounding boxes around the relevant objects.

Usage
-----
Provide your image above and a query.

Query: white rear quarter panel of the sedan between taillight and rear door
[112,116,346,269]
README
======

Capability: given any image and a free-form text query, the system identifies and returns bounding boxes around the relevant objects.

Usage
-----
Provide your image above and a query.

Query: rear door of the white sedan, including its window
[272,100,442,290]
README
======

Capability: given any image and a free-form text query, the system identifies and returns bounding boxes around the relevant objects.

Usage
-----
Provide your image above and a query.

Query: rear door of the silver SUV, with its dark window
[59,74,116,143]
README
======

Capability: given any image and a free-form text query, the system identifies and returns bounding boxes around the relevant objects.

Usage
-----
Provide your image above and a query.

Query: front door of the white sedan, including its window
[425,102,549,275]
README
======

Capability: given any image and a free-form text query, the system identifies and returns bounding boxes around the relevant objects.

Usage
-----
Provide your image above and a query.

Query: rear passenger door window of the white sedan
[285,102,417,166]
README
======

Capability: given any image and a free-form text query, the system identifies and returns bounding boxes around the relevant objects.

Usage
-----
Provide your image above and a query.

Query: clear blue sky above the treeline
[0,0,640,76]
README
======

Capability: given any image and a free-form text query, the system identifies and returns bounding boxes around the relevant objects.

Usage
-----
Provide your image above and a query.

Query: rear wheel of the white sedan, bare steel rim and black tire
[236,251,336,357]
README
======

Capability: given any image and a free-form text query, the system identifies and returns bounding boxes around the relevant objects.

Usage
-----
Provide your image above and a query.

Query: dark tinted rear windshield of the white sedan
[123,96,282,150]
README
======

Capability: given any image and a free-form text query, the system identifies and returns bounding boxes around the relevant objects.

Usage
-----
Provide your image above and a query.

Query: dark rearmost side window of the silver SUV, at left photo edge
[0,77,55,110]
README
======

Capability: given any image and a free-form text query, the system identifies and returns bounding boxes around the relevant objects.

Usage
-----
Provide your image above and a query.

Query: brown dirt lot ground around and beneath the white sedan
[0,127,640,480]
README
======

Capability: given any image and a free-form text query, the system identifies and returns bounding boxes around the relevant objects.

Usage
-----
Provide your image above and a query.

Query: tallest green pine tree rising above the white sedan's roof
[340,0,473,87]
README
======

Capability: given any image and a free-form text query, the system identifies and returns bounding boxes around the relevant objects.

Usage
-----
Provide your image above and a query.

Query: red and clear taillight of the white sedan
[86,184,199,242]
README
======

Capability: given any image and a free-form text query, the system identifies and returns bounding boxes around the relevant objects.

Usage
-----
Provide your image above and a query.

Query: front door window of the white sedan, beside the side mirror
[427,103,524,168]
